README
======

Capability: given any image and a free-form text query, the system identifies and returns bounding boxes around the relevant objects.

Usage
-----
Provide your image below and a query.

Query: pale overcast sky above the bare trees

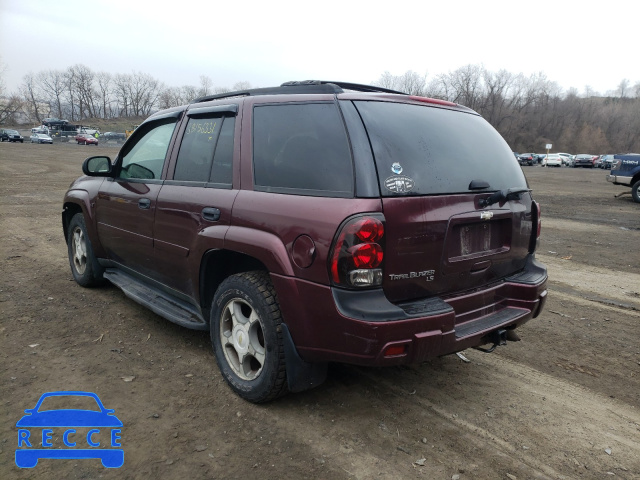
[0,0,640,93]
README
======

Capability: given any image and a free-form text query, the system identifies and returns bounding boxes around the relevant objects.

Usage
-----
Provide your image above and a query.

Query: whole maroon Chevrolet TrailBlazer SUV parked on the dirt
[62,81,547,402]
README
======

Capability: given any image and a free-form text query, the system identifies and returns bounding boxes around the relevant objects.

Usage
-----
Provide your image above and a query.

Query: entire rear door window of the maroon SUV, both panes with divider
[173,117,235,185]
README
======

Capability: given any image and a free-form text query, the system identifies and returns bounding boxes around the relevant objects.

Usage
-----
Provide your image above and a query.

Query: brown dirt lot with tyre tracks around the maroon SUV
[0,143,640,480]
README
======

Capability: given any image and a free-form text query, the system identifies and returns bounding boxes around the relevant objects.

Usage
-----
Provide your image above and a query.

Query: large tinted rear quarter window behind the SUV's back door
[253,103,353,196]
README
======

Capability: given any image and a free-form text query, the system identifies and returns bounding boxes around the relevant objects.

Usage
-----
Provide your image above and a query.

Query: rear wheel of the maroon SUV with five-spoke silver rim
[210,271,288,403]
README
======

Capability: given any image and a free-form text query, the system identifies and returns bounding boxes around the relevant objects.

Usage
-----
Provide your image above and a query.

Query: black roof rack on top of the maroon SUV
[191,80,407,104]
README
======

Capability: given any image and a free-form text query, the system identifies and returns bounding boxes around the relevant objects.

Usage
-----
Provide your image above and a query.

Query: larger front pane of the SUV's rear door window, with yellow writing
[173,118,223,182]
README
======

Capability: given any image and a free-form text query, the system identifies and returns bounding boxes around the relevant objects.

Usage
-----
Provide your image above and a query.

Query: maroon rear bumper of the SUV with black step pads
[272,256,547,366]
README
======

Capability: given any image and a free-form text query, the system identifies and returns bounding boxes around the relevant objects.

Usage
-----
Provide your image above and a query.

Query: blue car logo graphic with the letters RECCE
[16,391,124,468]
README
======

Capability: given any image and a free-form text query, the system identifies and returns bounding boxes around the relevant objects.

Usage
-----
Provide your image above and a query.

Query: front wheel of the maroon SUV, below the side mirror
[67,213,104,287]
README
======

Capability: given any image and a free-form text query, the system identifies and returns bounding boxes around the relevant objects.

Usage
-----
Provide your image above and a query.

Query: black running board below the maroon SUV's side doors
[104,268,209,330]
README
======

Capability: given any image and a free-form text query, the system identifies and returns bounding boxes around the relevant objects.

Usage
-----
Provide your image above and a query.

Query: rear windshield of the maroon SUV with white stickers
[354,101,527,196]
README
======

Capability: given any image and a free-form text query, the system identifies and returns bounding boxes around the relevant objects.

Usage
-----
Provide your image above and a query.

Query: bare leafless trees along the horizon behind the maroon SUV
[0,64,640,154]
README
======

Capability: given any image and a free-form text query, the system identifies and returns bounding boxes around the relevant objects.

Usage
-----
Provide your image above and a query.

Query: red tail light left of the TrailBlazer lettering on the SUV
[329,214,384,288]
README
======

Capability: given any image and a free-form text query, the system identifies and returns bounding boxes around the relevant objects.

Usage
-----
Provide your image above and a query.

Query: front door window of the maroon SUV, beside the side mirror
[120,119,176,180]
